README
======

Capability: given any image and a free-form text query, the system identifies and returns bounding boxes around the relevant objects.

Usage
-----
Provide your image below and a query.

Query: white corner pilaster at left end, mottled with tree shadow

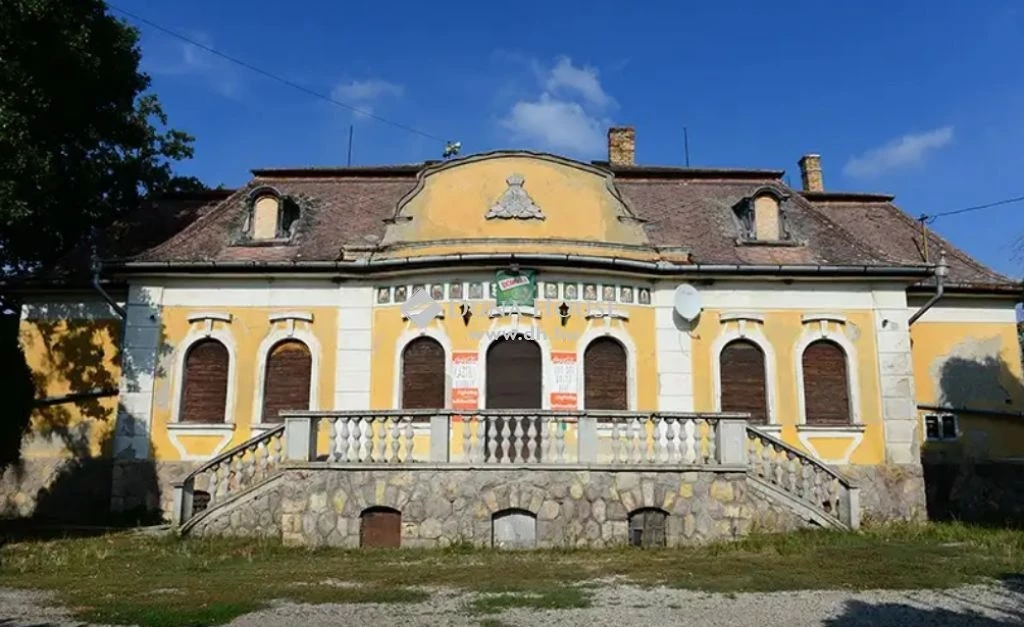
[114,285,164,459]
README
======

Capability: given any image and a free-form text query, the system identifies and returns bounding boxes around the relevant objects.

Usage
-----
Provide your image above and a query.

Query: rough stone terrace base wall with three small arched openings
[190,468,807,547]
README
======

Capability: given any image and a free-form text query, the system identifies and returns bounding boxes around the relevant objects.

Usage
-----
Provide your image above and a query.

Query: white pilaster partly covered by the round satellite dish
[651,283,693,412]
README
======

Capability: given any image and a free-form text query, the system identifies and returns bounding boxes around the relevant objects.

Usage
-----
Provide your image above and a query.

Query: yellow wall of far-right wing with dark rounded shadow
[910,322,1024,459]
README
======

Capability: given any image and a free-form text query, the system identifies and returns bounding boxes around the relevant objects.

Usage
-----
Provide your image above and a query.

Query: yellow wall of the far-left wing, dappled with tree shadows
[19,320,121,458]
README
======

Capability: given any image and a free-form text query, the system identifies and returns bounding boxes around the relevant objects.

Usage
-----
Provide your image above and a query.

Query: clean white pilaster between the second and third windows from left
[334,284,374,410]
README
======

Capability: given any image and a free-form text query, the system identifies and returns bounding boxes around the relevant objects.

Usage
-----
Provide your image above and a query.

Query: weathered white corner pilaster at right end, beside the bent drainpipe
[872,289,921,464]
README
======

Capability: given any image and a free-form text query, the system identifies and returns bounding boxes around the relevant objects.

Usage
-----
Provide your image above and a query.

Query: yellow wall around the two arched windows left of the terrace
[151,307,339,460]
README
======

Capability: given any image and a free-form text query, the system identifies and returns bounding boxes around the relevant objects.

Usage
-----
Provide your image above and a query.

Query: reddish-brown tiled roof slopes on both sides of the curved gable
[99,156,1014,286]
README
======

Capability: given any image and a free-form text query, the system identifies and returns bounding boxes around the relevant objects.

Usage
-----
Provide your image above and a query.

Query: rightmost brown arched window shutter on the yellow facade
[803,340,850,425]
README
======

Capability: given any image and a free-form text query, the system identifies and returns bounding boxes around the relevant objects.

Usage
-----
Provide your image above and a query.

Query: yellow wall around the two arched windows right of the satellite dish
[692,310,885,464]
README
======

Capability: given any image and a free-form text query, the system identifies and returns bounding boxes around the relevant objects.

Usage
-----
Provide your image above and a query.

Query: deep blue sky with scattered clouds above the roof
[115,0,1024,277]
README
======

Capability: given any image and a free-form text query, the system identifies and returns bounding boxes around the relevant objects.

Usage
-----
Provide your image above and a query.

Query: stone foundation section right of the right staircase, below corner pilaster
[838,464,928,525]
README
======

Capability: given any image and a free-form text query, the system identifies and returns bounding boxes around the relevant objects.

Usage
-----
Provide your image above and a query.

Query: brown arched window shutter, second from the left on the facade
[260,340,313,422]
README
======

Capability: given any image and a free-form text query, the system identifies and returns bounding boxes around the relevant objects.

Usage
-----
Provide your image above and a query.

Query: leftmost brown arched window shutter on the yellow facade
[179,339,228,422]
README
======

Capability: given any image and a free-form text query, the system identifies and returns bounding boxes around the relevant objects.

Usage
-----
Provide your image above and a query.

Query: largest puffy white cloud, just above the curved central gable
[501,56,616,156]
